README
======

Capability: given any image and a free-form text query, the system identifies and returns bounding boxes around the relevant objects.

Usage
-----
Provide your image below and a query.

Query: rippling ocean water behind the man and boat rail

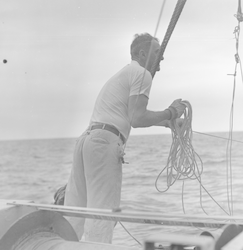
[0,132,243,246]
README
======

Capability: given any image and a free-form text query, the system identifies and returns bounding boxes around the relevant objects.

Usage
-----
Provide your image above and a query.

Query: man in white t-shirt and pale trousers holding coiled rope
[64,33,185,243]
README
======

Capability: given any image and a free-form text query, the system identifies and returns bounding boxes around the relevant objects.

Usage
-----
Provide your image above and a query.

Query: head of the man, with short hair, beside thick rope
[130,33,160,71]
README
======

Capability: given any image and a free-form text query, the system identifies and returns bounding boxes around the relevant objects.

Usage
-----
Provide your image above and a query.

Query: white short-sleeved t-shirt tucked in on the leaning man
[90,61,152,139]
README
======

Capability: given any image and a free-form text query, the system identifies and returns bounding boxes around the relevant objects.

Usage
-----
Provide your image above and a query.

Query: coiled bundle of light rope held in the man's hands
[155,101,203,192]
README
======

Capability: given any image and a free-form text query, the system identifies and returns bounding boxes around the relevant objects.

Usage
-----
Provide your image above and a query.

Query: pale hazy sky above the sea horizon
[0,0,243,140]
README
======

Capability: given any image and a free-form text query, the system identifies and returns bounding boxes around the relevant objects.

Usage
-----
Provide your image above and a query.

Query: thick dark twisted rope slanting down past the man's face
[151,0,186,78]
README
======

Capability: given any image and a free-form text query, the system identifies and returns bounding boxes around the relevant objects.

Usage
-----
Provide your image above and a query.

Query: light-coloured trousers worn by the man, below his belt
[64,129,124,243]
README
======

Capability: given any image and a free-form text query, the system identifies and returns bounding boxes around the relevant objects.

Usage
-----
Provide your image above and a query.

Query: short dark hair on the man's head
[130,33,159,58]
